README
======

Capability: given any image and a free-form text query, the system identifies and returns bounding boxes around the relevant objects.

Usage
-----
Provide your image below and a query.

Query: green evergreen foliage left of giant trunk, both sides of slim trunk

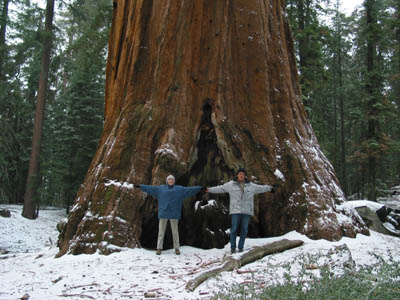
[0,0,112,209]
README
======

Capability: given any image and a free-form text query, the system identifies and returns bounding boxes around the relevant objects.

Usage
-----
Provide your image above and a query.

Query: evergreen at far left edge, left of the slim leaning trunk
[0,1,43,203]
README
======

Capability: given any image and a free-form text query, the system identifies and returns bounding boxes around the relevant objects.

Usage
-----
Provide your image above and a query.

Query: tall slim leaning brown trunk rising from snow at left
[22,0,55,219]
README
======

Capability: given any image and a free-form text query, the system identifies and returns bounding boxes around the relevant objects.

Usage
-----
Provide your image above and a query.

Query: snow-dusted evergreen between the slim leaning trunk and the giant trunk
[43,0,112,210]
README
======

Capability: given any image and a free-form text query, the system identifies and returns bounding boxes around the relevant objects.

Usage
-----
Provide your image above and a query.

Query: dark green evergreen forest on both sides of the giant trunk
[0,0,400,213]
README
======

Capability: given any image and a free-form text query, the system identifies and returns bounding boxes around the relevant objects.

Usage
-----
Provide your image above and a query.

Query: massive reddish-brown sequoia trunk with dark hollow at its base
[59,0,368,255]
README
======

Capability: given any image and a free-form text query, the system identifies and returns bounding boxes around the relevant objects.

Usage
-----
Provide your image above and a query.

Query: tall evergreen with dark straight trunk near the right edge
[353,0,394,201]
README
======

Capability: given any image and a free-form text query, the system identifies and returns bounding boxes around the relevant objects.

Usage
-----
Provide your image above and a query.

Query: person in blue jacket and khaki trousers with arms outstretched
[135,175,202,255]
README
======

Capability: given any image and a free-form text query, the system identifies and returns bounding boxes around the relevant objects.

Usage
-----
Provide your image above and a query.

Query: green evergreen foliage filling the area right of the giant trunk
[286,0,400,195]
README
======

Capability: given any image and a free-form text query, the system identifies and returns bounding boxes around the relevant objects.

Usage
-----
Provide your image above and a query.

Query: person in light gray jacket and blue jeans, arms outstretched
[207,168,279,253]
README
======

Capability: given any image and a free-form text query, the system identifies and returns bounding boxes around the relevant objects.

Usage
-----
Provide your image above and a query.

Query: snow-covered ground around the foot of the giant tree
[0,205,400,300]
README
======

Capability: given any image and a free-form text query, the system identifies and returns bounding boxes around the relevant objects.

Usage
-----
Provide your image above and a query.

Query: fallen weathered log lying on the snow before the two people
[186,239,304,291]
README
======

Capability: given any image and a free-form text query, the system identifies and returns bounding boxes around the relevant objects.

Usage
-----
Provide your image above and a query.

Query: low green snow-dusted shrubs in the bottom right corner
[211,261,400,300]
